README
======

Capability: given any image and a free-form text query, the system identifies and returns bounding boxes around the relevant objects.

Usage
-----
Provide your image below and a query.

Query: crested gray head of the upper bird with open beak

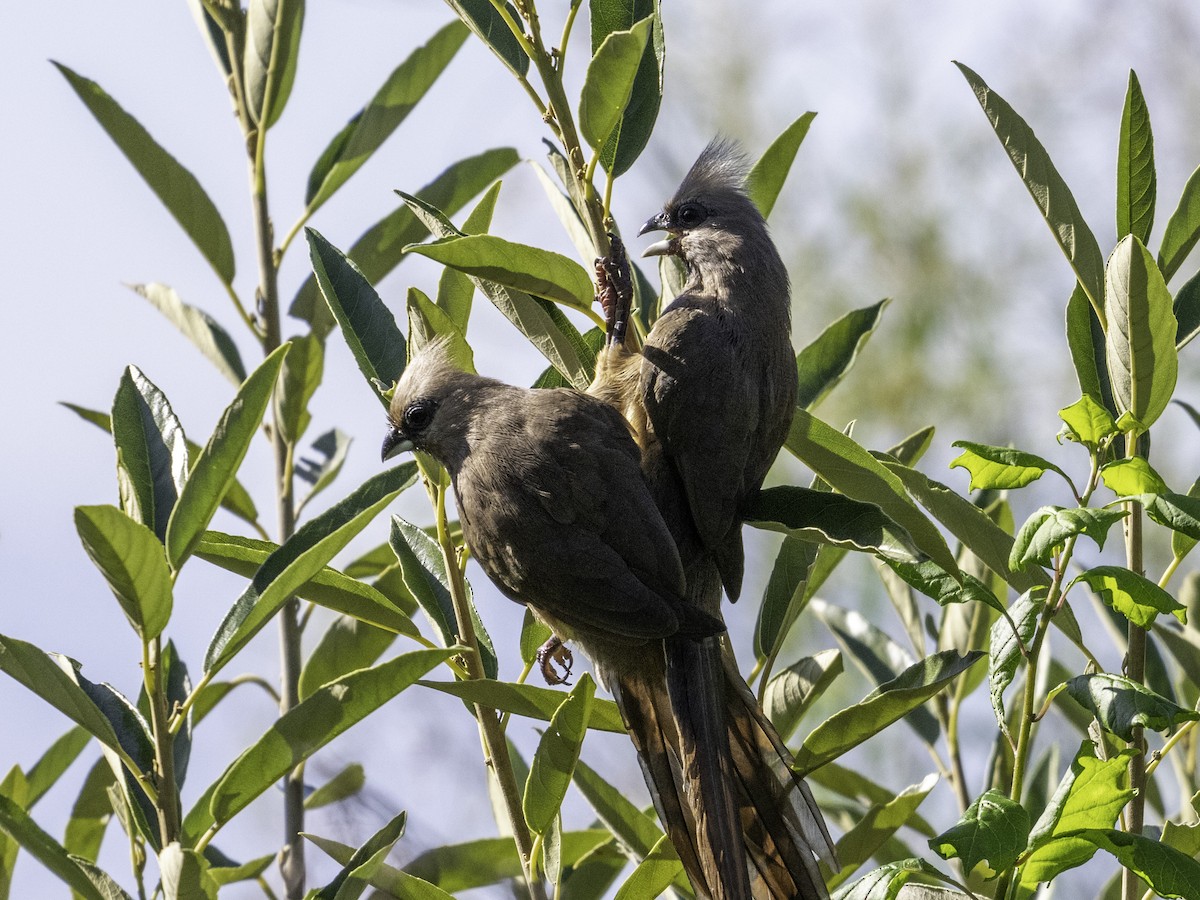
[638,138,767,266]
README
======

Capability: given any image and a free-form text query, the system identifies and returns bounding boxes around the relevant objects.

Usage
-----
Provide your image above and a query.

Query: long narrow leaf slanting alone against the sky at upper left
[54,62,234,284]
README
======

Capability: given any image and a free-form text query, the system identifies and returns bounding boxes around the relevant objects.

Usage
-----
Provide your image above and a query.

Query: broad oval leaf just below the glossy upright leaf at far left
[74,505,173,641]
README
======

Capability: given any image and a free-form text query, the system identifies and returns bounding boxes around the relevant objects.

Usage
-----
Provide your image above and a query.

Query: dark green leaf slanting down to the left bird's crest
[305,228,408,407]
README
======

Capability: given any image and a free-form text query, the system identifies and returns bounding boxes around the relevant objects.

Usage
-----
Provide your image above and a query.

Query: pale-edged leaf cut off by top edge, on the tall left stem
[242,0,304,128]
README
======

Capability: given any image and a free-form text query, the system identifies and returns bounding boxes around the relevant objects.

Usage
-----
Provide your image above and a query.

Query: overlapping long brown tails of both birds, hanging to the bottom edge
[610,637,833,900]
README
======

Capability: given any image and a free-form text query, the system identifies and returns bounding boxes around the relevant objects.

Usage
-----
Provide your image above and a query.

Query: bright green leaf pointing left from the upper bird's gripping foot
[409,234,594,310]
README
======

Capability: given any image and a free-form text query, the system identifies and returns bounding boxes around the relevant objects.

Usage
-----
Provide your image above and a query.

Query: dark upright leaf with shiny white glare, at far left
[109,366,187,540]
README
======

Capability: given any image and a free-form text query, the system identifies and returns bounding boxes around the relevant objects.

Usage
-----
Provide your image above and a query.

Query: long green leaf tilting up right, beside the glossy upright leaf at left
[166,344,290,570]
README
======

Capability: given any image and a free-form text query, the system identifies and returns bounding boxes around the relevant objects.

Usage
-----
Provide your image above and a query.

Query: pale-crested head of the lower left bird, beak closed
[382,341,485,463]
